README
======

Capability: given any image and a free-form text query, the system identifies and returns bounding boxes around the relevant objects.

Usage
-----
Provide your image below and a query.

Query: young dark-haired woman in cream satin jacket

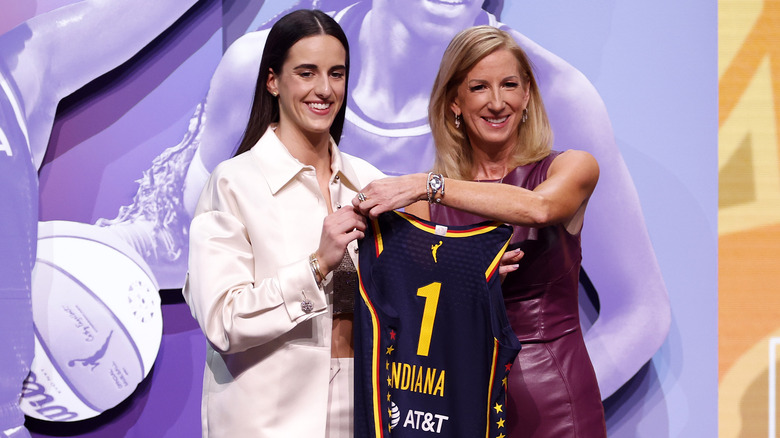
[184,10,382,438]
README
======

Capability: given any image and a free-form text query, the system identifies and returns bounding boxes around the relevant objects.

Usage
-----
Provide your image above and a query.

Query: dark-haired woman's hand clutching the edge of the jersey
[315,205,366,275]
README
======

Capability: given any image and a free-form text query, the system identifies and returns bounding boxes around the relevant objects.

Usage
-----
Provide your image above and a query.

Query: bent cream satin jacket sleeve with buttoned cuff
[183,169,327,353]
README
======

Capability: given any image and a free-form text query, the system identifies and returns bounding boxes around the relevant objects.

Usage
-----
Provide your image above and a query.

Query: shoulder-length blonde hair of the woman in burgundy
[428,26,552,180]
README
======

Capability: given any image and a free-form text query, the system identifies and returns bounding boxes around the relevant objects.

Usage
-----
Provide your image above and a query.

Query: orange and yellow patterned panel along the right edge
[718,0,780,438]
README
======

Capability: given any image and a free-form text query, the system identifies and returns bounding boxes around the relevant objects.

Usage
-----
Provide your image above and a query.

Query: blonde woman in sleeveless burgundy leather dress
[353,26,606,437]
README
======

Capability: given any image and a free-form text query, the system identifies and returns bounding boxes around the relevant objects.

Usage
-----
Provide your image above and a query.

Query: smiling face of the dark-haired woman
[266,35,347,143]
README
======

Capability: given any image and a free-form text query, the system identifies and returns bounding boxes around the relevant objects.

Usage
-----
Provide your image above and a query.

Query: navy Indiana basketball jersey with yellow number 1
[355,212,520,438]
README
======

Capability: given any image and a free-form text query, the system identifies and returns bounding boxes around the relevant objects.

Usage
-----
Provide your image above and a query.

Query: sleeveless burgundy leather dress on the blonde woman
[431,152,606,438]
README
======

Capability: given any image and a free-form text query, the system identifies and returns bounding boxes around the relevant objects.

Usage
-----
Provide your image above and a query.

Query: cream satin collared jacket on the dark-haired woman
[183,129,384,438]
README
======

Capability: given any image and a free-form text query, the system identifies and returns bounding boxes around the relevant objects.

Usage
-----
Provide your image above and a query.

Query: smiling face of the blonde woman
[451,49,530,150]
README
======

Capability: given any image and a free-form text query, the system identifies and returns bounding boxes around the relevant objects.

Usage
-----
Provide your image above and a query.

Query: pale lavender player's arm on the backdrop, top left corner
[0,0,195,166]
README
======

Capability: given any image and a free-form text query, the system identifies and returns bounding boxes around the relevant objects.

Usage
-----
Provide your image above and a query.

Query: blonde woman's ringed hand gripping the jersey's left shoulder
[352,173,428,219]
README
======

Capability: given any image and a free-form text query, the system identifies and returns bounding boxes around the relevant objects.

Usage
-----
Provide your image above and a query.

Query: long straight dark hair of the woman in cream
[236,9,349,155]
